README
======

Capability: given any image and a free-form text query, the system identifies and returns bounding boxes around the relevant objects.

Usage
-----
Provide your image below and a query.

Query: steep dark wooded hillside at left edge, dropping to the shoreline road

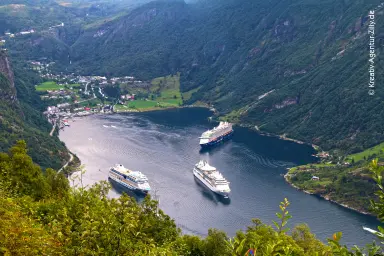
[0,51,69,168]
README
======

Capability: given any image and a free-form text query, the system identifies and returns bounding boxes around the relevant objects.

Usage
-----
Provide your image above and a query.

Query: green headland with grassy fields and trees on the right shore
[285,143,384,214]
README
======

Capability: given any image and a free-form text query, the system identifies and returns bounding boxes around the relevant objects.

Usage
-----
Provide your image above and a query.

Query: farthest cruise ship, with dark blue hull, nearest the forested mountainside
[200,122,233,147]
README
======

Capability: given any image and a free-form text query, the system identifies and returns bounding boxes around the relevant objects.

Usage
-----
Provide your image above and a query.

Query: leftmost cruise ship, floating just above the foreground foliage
[108,164,151,194]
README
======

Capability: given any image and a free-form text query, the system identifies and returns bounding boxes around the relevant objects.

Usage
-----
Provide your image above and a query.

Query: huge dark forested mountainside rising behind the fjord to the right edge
[60,0,384,152]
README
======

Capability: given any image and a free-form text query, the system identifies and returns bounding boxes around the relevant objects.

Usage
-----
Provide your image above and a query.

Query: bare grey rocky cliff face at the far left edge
[0,51,17,102]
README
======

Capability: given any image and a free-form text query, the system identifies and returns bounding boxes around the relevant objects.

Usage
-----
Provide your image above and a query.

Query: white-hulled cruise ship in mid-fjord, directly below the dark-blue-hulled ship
[193,160,231,197]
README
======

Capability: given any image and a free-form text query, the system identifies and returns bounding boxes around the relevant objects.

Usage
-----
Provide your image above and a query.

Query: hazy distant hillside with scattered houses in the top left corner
[0,0,154,65]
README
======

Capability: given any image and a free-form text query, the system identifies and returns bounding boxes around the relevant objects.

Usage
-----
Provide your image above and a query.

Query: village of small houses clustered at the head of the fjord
[29,61,146,130]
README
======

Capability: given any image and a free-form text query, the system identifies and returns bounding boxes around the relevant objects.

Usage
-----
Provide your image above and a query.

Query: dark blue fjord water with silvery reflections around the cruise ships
[60,108,379,245]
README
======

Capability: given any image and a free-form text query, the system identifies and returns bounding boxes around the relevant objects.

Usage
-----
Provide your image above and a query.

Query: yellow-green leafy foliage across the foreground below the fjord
[0,141,384,256]
